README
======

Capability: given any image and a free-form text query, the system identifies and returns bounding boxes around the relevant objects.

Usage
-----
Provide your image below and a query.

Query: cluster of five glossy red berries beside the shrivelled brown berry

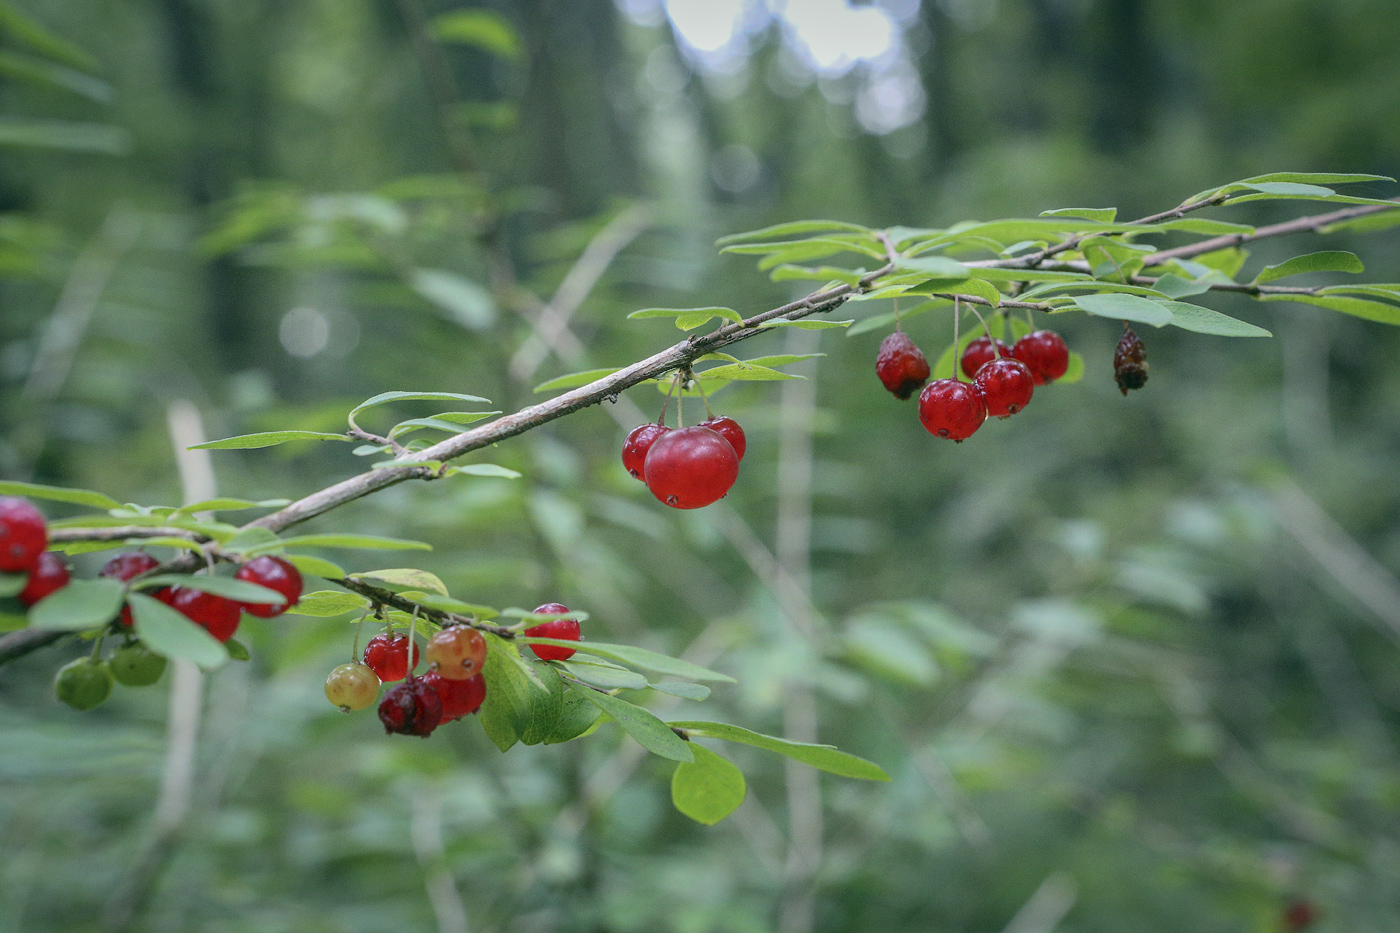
[875,331,1070,443]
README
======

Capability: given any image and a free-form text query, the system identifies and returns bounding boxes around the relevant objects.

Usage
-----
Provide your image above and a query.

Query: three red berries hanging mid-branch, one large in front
[621,417,748,509]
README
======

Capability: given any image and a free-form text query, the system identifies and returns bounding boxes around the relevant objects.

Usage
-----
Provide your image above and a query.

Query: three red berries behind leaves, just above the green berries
[98,551,302,642]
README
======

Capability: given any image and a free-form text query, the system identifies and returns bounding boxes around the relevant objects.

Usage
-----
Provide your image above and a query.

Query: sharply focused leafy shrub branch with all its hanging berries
[0,174,1400,824]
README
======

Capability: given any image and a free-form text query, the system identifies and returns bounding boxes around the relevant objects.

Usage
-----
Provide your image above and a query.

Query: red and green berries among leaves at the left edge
[0,497,301,710]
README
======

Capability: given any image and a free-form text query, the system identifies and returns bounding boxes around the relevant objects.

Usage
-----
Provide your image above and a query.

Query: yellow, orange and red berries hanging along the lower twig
[326,602,580,738]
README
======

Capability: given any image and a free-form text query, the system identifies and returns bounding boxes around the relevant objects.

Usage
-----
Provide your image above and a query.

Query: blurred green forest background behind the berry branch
[0,0,1400,933]
